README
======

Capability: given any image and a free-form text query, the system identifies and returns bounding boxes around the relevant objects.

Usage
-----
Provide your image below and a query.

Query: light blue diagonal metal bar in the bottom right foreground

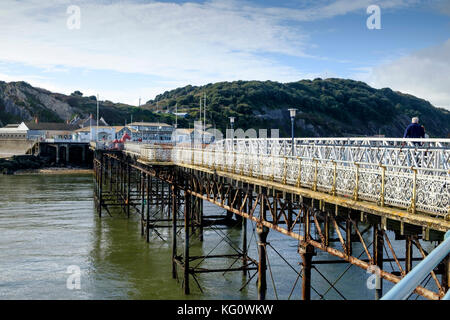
[381,231,450,300]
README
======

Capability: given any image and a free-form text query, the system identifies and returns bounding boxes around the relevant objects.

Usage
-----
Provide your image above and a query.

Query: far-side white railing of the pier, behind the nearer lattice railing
[216,138,450,169]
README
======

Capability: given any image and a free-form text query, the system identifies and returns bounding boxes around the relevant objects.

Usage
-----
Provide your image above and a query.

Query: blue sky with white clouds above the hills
[0,0,450,110]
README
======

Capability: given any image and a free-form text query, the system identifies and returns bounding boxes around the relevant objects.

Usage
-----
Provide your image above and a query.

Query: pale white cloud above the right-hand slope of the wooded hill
[367,39,450,110]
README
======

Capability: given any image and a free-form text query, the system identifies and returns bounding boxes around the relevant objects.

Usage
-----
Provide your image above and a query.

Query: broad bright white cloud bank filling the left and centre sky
[0,0,415,102]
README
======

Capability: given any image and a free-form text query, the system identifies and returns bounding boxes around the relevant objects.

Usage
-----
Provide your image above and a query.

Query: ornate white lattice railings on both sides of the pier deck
[125,138,450,217]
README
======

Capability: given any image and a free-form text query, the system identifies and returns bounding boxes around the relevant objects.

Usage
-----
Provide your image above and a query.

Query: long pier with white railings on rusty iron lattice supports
[91,138,450,300]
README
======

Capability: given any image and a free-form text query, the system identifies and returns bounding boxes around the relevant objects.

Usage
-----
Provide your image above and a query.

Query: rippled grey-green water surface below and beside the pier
[0,175,436,299]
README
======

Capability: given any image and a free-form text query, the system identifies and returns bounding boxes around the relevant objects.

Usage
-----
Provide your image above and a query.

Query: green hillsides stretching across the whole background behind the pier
[0,79,450,137]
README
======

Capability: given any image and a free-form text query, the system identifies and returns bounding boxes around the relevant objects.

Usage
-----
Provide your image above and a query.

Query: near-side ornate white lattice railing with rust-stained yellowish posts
[125,143,450,219]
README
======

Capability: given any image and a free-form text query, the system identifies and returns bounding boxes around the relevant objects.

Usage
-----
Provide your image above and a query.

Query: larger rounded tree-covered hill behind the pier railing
[146,78,450,137]
